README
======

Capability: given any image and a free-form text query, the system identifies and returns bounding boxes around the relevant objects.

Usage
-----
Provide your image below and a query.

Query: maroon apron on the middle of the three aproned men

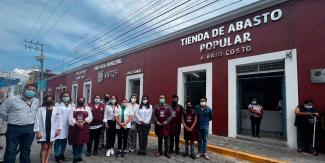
[170,105,182,136]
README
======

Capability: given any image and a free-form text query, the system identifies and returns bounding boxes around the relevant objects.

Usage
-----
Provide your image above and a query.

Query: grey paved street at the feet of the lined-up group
[26,138,243,163]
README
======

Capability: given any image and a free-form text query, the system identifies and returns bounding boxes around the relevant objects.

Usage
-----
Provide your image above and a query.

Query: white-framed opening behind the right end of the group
[177,63,214,134]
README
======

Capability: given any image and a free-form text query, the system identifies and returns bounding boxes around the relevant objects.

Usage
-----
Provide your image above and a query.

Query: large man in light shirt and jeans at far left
[0,84,39,163]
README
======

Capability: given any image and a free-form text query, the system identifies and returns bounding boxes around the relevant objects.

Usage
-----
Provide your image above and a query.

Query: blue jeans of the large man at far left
[4,124,34,163]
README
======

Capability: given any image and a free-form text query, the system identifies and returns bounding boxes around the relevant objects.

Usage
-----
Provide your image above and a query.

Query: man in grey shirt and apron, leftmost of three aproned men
[153,95,173,158]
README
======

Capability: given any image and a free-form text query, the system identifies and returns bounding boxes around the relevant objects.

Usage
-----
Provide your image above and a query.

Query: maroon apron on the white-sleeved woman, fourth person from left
[68,110,89,145]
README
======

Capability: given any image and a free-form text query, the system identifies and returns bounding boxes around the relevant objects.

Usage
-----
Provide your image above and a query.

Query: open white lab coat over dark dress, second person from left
[34,106,62,142]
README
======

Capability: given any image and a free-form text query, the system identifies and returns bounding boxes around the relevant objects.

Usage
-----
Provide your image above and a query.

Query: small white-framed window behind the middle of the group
[125,73,143,100]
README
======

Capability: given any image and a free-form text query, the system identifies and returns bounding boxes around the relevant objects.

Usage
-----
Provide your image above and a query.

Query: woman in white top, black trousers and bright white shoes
[103,96,120,157]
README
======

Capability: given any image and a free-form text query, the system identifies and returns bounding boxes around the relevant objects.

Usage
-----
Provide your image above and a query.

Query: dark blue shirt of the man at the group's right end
[195,105,212,129]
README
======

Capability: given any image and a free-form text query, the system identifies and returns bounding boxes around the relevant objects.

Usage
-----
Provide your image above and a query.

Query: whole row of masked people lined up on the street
[0,84,212,163]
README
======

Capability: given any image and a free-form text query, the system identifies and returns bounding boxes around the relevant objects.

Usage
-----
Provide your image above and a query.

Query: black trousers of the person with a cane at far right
[297,125,314,152]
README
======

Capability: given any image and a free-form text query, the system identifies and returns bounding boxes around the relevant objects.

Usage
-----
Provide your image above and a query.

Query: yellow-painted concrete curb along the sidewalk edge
[149,132,285,163]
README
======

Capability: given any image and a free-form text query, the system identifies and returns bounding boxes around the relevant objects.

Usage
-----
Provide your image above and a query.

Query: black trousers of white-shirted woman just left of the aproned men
[137,124,151,152]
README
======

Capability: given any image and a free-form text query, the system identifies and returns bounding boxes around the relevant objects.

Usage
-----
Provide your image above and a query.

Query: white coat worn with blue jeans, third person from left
[55,102,75,139]
